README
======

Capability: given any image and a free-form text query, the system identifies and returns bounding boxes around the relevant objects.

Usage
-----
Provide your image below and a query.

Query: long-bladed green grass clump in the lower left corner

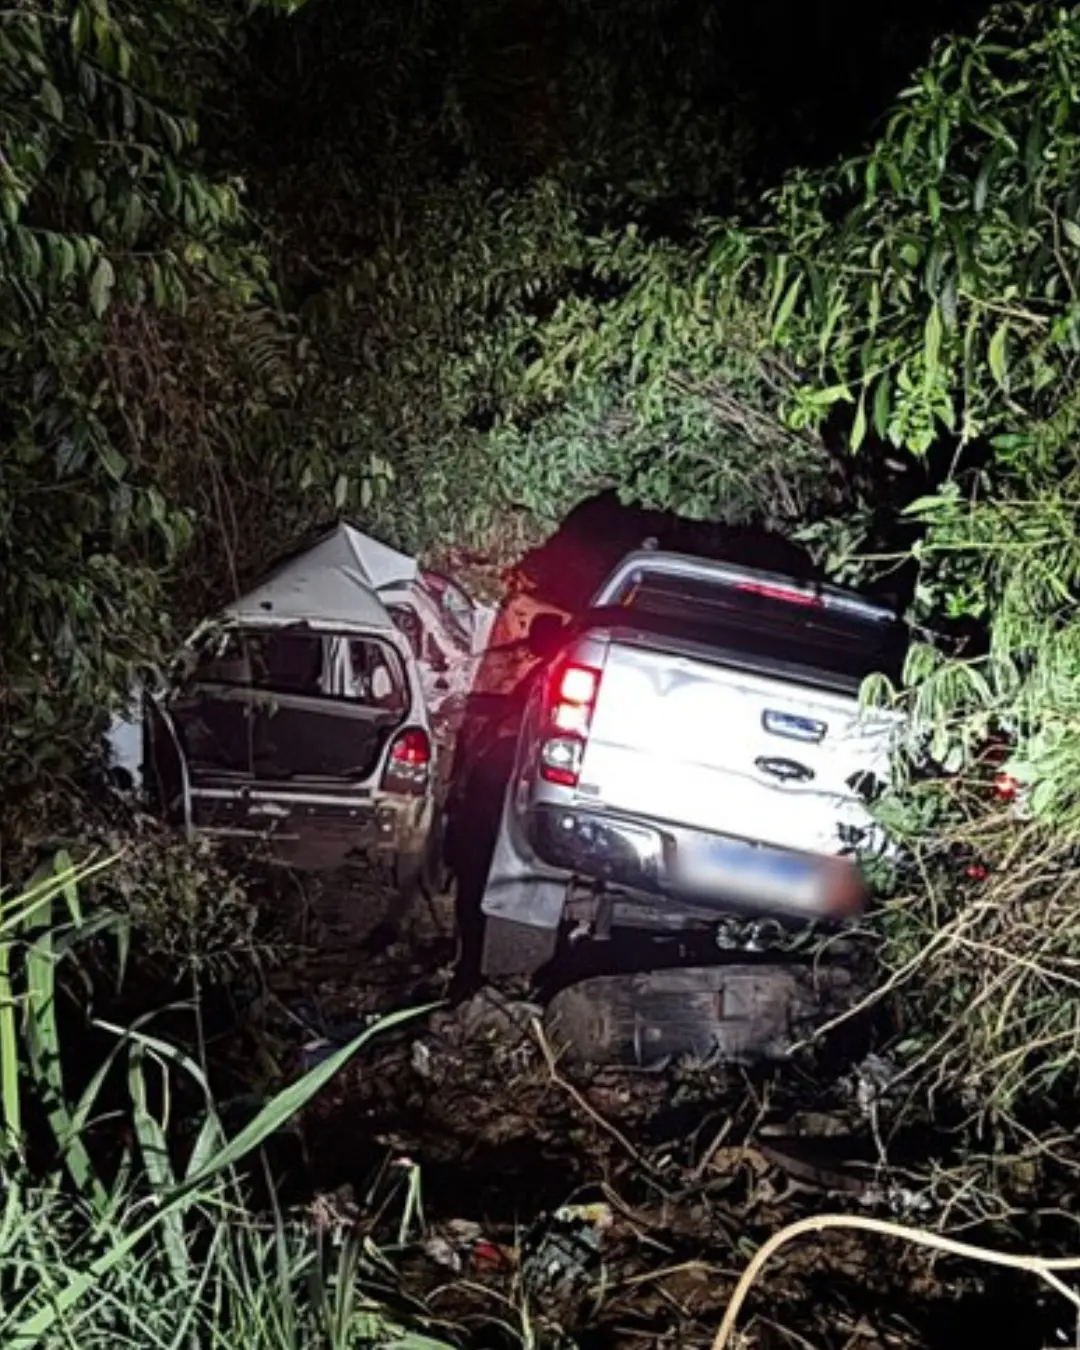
[0,860,443,1350]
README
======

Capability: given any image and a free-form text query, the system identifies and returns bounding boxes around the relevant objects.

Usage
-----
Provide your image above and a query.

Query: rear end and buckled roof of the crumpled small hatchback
[144,527,460,884]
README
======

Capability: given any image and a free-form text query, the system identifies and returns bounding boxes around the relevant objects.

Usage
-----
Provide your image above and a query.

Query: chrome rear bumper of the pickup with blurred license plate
[524,803,867,919]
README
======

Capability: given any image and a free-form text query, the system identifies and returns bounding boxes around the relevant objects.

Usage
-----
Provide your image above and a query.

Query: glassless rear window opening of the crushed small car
[194,629,408,713]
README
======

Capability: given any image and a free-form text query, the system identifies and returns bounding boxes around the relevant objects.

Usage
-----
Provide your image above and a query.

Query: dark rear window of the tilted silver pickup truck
[620,572,909,686]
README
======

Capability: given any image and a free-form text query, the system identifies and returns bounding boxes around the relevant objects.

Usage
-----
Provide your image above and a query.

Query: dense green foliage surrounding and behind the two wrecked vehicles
[0,0,1080,1252]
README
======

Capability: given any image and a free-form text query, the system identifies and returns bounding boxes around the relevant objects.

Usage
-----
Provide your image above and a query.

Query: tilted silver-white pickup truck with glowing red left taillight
[482,551,907,975]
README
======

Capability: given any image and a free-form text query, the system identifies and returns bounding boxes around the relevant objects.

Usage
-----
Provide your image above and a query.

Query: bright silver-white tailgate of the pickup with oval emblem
[579,641,898,853]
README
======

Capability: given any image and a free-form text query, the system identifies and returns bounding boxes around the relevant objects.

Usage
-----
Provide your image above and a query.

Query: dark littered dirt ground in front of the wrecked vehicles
[229,871,1060,1350]
